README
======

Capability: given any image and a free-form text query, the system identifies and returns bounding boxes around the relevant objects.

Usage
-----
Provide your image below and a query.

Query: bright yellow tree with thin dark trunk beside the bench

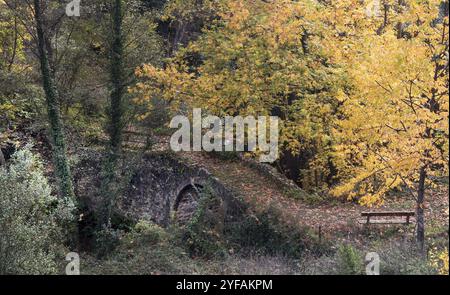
[324,0,449,249]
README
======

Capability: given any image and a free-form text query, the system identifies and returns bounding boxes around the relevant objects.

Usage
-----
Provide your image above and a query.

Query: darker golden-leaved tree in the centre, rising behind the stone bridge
[133,0,344,183]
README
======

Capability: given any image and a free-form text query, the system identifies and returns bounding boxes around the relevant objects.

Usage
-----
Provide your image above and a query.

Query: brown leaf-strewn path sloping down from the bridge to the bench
[147,137,449,243]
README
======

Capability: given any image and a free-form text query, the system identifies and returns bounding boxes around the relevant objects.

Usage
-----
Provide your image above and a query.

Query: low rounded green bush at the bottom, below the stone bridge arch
[83,221,202,275]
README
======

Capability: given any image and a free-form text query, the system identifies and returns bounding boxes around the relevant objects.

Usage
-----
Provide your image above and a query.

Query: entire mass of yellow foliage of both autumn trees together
[132,0,449,206]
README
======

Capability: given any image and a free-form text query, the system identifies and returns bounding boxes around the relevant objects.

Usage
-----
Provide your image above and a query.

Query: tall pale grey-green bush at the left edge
[0,147,74,274]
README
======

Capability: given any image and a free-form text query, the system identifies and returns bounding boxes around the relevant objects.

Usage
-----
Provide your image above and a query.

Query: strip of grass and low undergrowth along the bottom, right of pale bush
[81,207,448,275]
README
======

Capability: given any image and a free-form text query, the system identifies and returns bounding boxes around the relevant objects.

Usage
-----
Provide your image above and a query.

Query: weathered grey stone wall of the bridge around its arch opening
[74,153,240,226]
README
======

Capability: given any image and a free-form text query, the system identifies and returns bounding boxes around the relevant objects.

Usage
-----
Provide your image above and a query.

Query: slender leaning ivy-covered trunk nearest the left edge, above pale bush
[34,0,75,201]
